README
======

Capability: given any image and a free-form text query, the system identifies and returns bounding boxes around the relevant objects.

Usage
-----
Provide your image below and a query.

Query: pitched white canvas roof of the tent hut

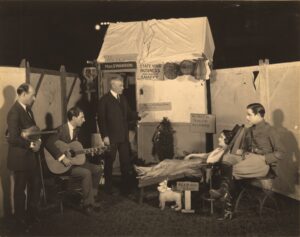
[97,17,215,63]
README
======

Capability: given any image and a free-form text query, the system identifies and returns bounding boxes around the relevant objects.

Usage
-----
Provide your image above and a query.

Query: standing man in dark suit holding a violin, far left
[7,83,41,228]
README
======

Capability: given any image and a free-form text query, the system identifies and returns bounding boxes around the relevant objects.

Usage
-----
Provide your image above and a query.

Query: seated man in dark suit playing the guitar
[46,107,101,215]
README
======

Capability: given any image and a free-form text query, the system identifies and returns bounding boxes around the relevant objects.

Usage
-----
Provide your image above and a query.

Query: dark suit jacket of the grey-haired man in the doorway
[98,92,139,143]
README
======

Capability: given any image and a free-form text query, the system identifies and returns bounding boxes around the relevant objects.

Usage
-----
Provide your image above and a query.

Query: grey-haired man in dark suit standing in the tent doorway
[98,76,146,195]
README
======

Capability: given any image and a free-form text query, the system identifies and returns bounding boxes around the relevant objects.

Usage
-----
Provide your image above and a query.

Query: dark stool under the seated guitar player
[56,175,82,214]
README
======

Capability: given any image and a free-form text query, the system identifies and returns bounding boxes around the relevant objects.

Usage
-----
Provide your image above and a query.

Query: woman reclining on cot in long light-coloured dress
[134,129,237,179]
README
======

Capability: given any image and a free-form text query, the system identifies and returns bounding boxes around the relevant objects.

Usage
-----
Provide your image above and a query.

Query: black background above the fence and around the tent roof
[0,1,300,73]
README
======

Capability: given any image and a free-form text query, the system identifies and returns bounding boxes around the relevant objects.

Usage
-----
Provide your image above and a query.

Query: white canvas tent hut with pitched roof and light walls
[97,17,215,161]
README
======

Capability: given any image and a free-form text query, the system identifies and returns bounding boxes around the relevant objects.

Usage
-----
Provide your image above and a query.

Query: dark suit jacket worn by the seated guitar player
[45,123,79,159]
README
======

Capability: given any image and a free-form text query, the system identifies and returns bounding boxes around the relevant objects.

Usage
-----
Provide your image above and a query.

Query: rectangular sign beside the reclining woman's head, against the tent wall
[190,114,216,133]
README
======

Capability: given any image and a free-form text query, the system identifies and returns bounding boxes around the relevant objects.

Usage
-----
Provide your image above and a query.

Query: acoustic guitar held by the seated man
[44,140,108,174]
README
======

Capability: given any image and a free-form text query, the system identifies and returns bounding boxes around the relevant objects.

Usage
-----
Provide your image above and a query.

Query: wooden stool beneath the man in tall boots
[234,172,279,216]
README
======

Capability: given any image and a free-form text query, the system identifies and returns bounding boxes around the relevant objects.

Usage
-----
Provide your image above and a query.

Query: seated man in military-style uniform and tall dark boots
[210,103,285,219]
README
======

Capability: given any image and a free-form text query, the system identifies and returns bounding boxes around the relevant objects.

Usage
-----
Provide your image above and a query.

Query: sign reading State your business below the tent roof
[139,63,163,80]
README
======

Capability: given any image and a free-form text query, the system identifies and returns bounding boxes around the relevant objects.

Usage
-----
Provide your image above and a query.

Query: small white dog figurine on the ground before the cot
[157,180,182,211]
